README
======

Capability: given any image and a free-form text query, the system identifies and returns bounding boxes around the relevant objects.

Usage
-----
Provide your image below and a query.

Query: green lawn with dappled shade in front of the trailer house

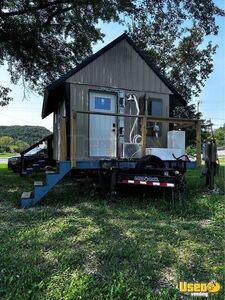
[0,165,224,300]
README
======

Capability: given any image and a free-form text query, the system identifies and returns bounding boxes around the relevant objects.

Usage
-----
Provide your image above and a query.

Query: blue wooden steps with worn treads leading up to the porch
[21,161,71,208]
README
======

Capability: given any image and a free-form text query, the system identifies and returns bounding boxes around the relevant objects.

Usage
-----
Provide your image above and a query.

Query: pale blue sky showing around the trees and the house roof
[0,0,225,131]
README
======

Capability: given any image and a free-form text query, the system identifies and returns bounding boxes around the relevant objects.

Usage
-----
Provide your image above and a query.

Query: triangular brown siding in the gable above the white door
[67,40,171,94]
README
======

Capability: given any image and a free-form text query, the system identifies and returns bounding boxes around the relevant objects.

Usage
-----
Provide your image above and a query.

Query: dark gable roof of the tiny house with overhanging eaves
[42,33,186,118]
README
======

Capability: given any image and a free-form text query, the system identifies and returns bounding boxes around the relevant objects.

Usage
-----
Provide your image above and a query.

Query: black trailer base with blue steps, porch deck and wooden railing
[21,111,201,208]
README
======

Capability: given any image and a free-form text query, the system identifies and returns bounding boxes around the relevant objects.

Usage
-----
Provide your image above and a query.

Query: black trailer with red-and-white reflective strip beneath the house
[73,155,189,200]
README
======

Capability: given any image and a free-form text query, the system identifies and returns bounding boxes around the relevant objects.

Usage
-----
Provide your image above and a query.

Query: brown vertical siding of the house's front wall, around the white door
[67,40,171,159]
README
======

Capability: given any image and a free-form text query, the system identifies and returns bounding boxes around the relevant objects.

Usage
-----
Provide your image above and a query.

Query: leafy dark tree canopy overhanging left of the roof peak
[0,0,135,105]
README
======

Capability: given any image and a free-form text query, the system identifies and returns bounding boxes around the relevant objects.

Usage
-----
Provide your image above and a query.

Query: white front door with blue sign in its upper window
[89,92,117,157]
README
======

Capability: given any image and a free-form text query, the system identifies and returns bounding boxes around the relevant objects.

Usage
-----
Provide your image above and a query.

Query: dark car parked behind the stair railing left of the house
[8,147,48,172]
